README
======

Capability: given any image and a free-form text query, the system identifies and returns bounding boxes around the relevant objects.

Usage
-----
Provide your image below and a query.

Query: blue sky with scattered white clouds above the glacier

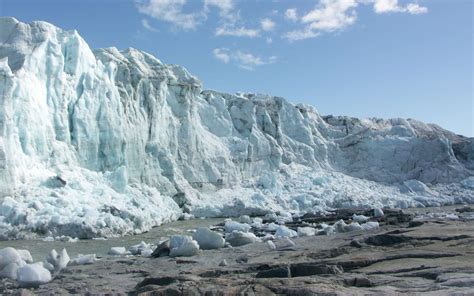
[0,0,474,136]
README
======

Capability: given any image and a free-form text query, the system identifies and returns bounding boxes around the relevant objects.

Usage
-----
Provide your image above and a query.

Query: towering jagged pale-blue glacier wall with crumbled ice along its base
[0,18,474,238]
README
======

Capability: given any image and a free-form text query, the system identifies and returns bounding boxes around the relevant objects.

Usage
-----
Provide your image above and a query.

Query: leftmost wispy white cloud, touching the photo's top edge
[137,0,203,30]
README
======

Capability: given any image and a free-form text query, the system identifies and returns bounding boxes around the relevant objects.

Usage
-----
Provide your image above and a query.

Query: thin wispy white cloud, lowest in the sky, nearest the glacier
[213,48,277,71]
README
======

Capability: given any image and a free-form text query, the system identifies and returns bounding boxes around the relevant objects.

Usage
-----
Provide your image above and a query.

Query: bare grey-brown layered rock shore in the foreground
[0,206,474,295]
